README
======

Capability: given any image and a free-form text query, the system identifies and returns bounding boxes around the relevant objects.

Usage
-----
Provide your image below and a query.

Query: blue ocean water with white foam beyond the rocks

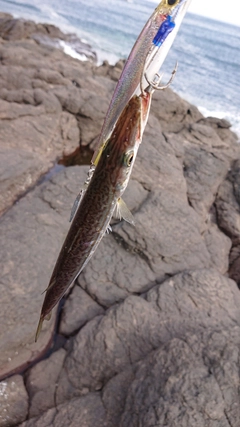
[0,0,240,136]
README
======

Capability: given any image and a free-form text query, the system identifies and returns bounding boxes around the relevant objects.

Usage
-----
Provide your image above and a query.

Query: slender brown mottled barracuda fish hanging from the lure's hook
[35,87,152,341]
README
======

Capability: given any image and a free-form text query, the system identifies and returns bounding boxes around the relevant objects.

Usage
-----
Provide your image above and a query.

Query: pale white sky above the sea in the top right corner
[152,0,240,27]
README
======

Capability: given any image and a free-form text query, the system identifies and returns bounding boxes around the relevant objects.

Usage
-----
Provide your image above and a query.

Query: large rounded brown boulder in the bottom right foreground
[54,270,240,426]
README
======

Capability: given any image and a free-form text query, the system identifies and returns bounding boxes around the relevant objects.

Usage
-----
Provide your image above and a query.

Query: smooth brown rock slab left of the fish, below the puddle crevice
[0,167,88,378]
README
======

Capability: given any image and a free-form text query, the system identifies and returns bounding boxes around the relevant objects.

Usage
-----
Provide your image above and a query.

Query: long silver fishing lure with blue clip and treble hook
[92,0,191,165]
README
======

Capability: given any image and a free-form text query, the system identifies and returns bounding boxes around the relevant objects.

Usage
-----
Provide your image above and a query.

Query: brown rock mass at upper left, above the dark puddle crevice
[0,16,100,217]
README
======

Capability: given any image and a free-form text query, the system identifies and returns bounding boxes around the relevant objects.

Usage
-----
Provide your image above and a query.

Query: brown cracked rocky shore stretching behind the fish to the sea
[0,14,240,427]
